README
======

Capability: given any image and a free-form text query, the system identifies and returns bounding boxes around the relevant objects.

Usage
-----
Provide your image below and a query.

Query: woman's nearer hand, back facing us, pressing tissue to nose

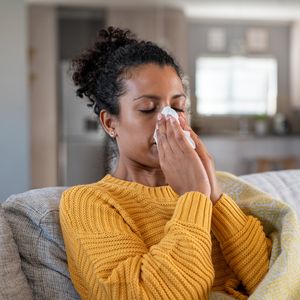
[157,114,211,197]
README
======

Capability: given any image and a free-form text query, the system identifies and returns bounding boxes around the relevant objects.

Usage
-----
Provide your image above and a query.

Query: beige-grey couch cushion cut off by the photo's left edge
[0,205,32,300]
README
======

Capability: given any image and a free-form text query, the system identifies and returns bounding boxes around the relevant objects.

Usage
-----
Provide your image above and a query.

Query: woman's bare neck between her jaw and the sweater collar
[112,159,167,187]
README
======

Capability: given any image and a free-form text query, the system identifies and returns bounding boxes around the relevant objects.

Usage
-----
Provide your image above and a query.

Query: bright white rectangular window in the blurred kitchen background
[196,57,277,115]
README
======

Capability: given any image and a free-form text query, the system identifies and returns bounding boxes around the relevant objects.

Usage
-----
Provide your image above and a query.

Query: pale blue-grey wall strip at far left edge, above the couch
[0,0,30,201]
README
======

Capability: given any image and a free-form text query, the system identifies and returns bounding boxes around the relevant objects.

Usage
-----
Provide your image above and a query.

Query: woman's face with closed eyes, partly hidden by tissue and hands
[116,64,186,168]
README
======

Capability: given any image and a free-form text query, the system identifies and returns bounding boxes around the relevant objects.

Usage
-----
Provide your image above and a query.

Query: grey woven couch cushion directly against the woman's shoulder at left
[2,187,79,300]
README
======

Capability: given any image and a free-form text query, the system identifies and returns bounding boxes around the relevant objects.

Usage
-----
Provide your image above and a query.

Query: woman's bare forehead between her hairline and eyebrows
[125,64,183,94]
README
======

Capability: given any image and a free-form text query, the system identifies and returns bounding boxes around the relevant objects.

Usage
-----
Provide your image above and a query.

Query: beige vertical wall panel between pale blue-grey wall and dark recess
[29,6,58,188]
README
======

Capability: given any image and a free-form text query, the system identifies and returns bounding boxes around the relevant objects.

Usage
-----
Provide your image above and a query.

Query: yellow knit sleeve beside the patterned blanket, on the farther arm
[212,194,271,294]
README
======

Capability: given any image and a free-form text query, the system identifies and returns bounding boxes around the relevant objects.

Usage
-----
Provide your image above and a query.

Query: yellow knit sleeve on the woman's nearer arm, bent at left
[60,187,214,299]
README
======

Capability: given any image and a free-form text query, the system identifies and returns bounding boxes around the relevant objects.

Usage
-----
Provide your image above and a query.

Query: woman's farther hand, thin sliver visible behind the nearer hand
[179,113,222,204]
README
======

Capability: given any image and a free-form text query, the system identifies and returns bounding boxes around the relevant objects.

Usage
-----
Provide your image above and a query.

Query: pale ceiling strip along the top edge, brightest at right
[25,0,300,22]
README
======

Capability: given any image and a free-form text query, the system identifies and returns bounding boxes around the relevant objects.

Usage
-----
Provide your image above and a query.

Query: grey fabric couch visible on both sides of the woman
[0,170,300,300]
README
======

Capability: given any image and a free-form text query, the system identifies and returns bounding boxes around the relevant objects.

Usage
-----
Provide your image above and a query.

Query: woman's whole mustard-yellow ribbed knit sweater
[60,175,269,300]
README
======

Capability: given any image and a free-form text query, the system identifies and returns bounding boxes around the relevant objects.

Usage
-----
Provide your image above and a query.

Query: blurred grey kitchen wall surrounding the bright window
[188,20,299,133]
